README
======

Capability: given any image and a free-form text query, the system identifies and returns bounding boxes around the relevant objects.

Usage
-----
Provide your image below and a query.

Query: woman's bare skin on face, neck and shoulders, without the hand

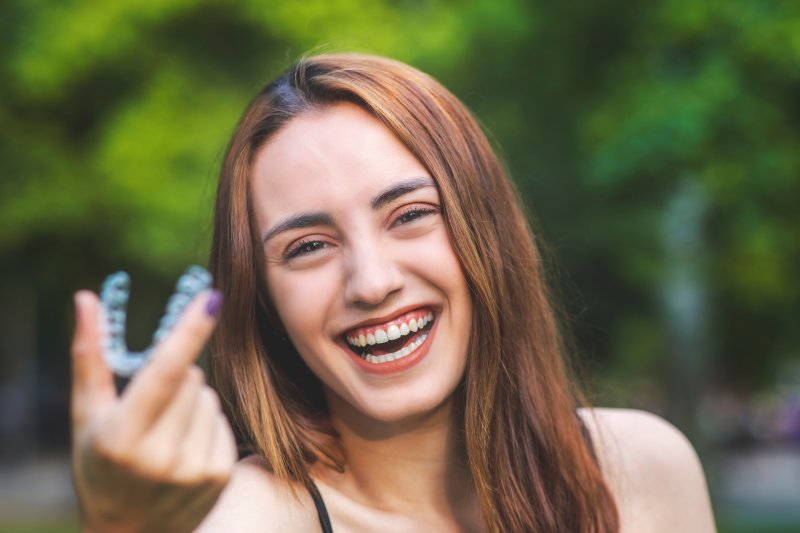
[204,104,714,532]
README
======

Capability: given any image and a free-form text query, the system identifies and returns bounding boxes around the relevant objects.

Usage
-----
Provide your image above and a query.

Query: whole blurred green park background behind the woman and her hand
[0,0,800,532]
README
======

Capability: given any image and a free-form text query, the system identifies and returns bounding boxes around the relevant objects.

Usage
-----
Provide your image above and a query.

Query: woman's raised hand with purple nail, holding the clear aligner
[72,291,236,532]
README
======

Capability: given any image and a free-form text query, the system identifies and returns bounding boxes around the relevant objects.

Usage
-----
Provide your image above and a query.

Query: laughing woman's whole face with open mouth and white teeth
[251,103,472,422]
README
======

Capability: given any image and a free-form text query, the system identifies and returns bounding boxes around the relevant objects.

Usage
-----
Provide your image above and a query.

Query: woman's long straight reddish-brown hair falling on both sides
[211,54,618,532]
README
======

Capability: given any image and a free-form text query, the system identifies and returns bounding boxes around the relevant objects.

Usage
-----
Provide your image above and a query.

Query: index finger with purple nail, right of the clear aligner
[120,291,222,431]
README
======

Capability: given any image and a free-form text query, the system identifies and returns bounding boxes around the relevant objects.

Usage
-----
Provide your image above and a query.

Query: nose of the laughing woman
[344,240,405,307]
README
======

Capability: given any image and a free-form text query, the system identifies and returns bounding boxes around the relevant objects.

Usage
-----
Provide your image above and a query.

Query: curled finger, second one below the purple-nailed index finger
[175,387,222,482]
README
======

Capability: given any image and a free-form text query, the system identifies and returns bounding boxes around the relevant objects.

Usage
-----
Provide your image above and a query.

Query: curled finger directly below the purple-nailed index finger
[134,366,205,474]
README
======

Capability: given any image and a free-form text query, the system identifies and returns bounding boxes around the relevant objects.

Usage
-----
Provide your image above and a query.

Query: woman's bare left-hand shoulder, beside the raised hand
[196,456,319,533]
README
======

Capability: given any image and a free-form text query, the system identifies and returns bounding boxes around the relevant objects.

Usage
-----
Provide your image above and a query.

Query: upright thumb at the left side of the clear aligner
[72,291,117,426]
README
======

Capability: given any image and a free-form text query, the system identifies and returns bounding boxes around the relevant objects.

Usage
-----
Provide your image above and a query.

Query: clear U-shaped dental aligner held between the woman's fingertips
[100,266,212,378]
